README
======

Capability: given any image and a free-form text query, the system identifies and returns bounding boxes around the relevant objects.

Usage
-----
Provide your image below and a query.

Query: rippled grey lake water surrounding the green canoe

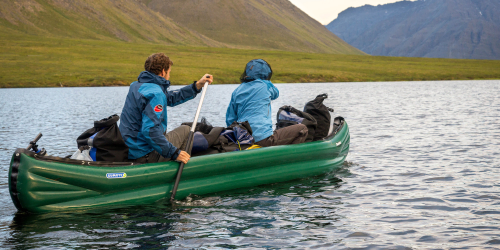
[0,81,500,249]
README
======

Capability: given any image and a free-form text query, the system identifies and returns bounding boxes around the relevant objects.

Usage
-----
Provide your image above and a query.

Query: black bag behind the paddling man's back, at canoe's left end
[76,115,128,162]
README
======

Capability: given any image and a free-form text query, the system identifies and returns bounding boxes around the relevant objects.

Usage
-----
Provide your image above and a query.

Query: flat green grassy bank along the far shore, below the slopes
[0,35,500,88]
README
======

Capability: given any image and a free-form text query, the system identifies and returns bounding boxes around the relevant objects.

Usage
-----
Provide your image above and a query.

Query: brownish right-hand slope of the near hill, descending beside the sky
[142,0,364,54]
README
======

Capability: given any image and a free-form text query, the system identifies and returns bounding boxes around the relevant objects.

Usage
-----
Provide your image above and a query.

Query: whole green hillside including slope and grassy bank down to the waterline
[0,0,500,88]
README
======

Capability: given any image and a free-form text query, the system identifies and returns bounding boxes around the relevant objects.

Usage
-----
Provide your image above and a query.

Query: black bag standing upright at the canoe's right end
[304,94,333,141]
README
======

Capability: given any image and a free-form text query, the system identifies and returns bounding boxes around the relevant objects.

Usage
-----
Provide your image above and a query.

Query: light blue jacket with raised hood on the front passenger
[226,60,279,142]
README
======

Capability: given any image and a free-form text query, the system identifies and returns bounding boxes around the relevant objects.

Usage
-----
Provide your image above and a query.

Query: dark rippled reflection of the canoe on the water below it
[4,168,347,249]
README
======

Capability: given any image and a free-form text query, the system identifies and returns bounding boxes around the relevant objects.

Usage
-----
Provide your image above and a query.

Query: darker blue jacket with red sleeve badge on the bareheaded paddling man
[120,71,199,159]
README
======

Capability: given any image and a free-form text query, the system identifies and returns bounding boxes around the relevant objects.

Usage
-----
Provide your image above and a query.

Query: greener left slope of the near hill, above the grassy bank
[0,0,222,46]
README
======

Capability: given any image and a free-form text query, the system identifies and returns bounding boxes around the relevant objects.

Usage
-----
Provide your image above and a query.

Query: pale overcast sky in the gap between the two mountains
[290,0,410,25]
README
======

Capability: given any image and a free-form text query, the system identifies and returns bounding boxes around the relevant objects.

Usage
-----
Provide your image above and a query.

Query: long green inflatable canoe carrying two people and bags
[9,121,350,213]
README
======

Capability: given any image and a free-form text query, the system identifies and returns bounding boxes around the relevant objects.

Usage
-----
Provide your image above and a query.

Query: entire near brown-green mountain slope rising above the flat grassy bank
[0,0,364,54]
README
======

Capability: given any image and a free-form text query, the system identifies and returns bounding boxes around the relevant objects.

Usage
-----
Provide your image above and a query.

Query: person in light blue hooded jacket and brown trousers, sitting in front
[226,59,308,147]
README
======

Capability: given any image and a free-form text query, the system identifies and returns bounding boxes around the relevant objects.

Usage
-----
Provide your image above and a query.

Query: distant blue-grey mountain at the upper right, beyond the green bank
[326,0,500,60]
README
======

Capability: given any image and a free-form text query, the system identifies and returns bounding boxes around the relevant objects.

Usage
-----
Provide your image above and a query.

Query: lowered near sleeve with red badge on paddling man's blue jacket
[141,94,178,159]
